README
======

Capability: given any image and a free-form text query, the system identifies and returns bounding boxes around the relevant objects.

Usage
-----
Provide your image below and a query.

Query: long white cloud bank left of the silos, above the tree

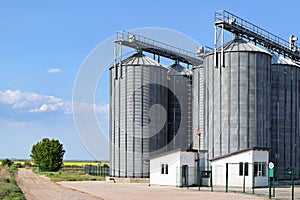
[0,90,109,114]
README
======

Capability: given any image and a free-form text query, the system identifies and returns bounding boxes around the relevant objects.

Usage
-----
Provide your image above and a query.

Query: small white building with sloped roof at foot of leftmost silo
[149,150,205,186]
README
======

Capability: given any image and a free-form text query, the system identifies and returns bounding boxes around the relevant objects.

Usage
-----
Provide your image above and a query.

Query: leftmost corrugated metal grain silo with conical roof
[110,52,168,178]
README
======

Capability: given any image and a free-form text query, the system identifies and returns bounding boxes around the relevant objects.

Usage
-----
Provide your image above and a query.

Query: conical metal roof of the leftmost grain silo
[122,52,163,67]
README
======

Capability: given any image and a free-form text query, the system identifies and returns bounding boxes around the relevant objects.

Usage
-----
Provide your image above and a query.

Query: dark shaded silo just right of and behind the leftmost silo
[167,62,192,150]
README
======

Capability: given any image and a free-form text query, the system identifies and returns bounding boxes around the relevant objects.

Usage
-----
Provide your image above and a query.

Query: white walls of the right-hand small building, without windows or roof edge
[211,150,269,187]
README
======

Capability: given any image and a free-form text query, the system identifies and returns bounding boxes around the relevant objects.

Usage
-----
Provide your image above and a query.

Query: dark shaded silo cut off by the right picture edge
[270,57,300,179]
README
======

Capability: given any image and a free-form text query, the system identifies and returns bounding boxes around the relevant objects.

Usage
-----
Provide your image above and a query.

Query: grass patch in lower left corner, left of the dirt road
[0,165,25,200]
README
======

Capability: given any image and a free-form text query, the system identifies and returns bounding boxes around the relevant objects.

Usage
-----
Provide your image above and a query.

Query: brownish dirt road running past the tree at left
[16,168,101,200]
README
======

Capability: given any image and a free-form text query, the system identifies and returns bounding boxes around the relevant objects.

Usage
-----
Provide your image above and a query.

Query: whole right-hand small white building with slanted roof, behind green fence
[211,148,269,187]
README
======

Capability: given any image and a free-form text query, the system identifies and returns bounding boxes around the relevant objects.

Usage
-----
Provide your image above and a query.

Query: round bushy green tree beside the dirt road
[30,138,66,171]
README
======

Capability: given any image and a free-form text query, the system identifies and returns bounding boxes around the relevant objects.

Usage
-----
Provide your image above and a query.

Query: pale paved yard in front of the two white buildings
[59,181,266,200]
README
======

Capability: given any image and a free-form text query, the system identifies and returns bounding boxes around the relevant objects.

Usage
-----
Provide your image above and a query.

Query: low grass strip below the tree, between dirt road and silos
[33,168,105,182]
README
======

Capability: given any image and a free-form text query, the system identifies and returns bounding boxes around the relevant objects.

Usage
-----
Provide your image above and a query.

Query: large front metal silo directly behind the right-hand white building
[204,38,271,158]
